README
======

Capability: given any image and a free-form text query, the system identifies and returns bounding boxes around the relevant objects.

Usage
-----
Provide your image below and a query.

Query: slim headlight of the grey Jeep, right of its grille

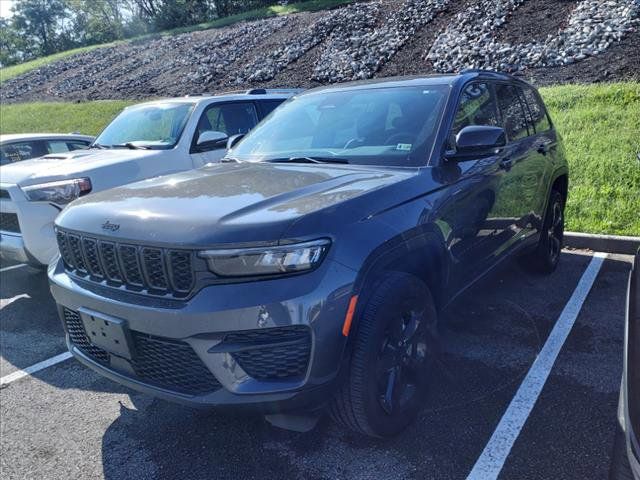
[200,239,331,277]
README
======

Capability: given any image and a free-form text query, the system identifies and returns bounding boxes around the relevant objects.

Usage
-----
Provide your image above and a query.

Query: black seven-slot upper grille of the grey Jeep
[56,229,195,297]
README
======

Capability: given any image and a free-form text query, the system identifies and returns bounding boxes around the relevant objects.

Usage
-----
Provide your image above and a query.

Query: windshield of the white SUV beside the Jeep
[94,103,193,149]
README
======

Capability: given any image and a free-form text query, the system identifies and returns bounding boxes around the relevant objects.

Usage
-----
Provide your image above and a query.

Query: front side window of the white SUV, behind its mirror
[198,102,258,136]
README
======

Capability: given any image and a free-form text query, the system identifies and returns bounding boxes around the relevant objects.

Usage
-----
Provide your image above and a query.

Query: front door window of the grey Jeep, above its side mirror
[452,83,499,136]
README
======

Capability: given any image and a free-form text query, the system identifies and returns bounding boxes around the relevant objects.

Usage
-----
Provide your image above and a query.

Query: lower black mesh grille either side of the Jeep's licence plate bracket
[63,308,220,395]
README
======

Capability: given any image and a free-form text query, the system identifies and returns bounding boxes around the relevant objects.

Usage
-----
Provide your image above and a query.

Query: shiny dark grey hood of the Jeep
[56,163,415,247]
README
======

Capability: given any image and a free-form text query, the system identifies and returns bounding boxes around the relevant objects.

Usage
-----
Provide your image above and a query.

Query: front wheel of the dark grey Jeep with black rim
[329,272,437,437]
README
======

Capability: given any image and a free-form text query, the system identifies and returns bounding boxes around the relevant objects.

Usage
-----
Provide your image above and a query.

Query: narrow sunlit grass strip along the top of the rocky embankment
[0,0,355,83]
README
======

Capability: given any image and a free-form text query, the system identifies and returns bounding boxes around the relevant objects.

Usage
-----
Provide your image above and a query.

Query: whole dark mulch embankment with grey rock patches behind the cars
[0,0,640,102]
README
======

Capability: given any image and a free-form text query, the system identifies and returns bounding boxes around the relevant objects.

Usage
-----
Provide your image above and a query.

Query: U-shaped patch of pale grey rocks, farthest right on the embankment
[426,0,640,72]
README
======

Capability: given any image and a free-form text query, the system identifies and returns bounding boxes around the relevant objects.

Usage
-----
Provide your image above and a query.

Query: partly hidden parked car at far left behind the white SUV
[0,133,93,165]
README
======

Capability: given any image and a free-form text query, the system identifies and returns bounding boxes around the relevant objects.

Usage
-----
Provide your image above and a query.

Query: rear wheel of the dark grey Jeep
[524,190,564,274]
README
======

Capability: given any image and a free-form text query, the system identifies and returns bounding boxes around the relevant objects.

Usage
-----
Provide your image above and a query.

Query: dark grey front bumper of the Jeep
[49,259,356,413]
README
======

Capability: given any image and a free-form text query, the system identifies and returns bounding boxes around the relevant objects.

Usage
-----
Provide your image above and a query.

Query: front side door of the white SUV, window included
[190,101,258,167]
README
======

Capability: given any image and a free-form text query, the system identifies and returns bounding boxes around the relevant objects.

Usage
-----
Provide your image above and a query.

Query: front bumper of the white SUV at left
[0,184,60,266]
